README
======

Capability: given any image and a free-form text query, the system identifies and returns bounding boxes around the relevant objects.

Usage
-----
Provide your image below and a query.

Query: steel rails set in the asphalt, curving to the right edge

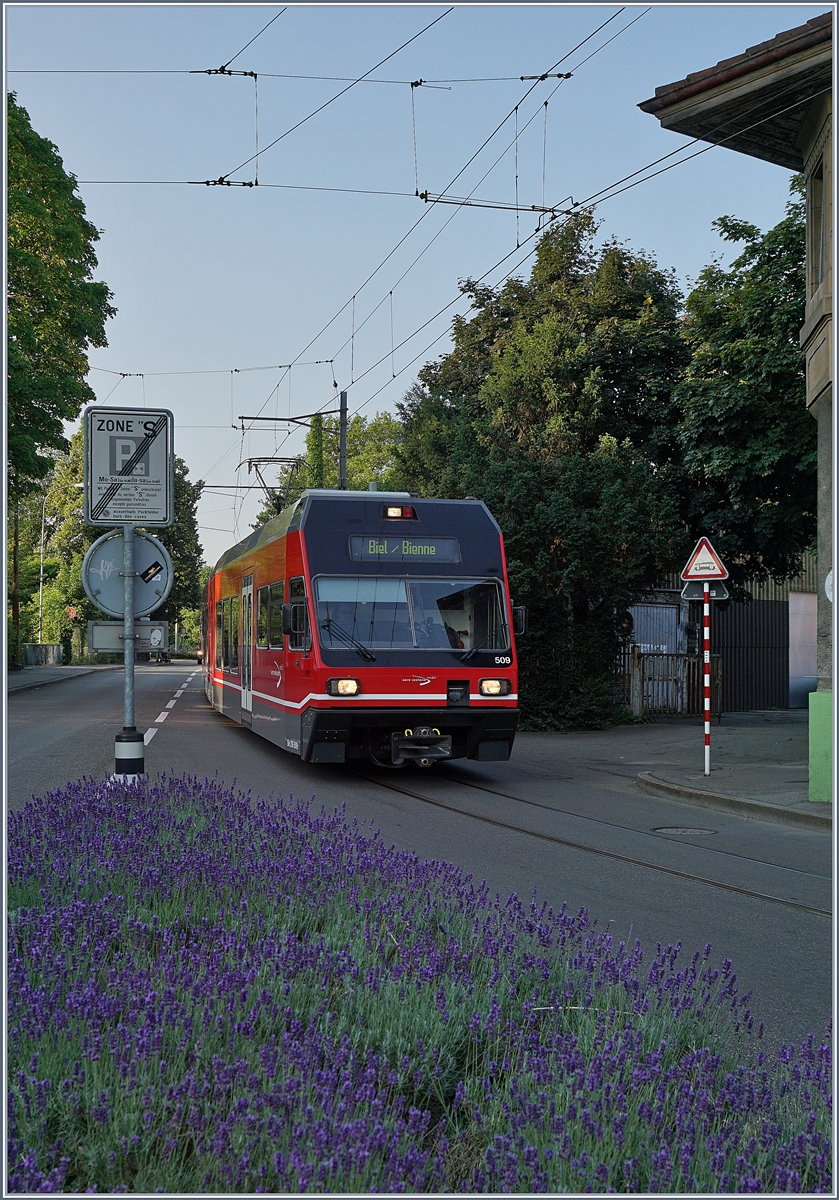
[352,772,833,919]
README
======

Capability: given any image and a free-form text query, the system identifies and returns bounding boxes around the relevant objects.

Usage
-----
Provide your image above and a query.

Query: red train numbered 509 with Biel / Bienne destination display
[203,490,523,767]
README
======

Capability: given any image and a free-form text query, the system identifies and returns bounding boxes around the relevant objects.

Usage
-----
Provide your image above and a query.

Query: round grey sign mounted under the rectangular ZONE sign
[82,529,174,617]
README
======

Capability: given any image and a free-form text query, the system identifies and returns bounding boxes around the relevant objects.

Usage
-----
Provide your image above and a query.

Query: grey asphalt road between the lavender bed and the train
[7,665,833,1045]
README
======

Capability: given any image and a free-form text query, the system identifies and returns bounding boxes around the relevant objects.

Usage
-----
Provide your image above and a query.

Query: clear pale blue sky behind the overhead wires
[5,4,827,563]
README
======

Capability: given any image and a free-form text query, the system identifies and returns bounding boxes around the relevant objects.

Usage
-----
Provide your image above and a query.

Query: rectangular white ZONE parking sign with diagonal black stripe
[84,406,174,529]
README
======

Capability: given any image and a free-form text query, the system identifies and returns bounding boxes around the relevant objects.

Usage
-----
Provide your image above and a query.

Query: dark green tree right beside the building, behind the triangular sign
[677,176,816,584]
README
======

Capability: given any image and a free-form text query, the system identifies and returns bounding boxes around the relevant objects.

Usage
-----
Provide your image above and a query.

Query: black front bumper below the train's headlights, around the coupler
[300,706,519,764]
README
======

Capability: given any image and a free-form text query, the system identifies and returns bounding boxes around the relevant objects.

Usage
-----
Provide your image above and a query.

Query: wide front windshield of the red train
[314,576,510,650]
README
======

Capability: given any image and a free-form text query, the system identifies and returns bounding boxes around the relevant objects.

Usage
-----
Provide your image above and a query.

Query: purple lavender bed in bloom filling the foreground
[7,776,832,1193]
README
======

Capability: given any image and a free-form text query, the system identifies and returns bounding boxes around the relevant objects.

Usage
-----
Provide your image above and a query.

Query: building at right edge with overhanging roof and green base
[639,12,834,800]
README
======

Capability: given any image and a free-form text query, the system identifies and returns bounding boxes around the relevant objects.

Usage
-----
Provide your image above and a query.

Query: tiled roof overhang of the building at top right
[639,12,833,170]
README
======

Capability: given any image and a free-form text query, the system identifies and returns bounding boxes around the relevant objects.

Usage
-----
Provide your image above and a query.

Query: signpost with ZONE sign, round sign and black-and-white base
[82,406,174,781]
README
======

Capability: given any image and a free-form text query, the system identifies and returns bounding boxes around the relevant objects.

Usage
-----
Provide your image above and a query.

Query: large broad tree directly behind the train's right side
[397,212,687,728]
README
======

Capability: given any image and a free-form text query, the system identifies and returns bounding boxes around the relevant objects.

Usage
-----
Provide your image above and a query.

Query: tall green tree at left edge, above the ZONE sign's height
[7,94,115,496]
